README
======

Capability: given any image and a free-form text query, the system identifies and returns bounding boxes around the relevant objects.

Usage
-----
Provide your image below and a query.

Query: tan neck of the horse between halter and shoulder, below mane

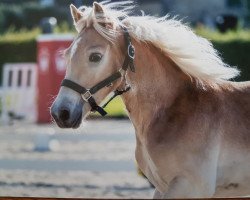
[122,42,190,134]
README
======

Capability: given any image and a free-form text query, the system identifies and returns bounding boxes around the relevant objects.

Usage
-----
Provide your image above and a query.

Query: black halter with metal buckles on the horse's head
[61,27,135,116]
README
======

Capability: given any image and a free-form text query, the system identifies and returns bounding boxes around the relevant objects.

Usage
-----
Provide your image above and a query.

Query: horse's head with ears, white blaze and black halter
[51,2,130,128]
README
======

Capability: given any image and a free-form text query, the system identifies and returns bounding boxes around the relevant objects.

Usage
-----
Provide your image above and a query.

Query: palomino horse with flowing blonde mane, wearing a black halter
[51,2,250,198]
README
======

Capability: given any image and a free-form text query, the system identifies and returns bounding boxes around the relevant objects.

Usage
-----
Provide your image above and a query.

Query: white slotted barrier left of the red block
[0,63,37,123]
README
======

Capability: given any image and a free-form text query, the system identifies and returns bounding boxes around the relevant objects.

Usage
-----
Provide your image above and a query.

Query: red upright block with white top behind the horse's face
[37,34,73,123]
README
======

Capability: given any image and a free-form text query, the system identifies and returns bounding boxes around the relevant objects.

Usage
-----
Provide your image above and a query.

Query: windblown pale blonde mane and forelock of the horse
[75,1,240,83]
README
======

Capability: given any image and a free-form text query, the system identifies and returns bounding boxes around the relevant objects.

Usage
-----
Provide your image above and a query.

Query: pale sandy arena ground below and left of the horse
[0,120,153,198]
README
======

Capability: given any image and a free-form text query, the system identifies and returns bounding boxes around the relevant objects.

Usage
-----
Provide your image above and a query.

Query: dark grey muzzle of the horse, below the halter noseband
[50,98,83,128]
